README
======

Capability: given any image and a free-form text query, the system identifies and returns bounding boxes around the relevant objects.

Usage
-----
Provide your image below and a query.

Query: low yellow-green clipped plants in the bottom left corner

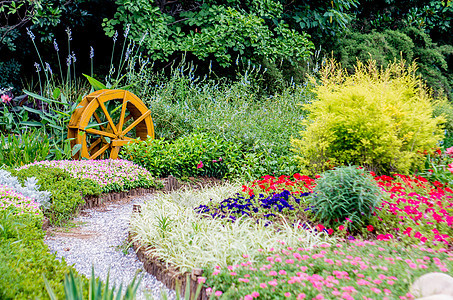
[0,207,72,299]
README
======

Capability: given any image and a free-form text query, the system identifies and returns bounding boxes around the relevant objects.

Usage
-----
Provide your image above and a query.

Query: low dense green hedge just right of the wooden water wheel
[120,133,296,180]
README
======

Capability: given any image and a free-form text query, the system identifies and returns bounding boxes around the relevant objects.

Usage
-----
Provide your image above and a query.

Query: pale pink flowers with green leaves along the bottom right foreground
[202,240,453,299]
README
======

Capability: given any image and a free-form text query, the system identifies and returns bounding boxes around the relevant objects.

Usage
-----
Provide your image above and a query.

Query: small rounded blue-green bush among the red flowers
[309,166,382,226]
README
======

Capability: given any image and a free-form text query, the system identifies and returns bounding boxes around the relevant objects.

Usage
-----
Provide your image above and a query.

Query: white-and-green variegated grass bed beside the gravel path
[130,187,329,272]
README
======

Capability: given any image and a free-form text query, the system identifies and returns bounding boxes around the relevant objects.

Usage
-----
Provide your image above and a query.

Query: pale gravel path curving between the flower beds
[45,195,174,299]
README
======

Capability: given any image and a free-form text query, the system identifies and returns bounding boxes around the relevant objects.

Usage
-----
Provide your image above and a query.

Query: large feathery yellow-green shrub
[292,60,444,173]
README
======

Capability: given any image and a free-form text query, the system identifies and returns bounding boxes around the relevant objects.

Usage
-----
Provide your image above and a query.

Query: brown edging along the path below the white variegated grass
[128,232,209,300]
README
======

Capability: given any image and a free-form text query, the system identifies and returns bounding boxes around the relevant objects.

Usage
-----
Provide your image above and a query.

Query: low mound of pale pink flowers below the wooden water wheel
[18,159,161,193]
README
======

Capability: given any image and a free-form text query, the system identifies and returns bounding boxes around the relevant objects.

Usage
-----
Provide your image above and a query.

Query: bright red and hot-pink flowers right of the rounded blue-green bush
[374,174,453,247]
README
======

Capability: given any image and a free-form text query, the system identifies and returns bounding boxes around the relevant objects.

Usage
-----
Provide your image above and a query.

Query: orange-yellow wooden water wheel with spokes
[68,90,154,159]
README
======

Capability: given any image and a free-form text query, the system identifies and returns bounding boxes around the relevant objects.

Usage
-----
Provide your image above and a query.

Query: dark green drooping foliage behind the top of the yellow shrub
[333,27,453,99]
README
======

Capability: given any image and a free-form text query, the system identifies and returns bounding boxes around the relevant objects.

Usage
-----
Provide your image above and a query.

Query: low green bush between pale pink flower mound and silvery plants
[11,166,101,224]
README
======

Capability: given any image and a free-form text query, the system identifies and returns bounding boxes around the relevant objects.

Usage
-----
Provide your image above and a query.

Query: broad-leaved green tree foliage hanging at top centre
[104,0,340,66]
